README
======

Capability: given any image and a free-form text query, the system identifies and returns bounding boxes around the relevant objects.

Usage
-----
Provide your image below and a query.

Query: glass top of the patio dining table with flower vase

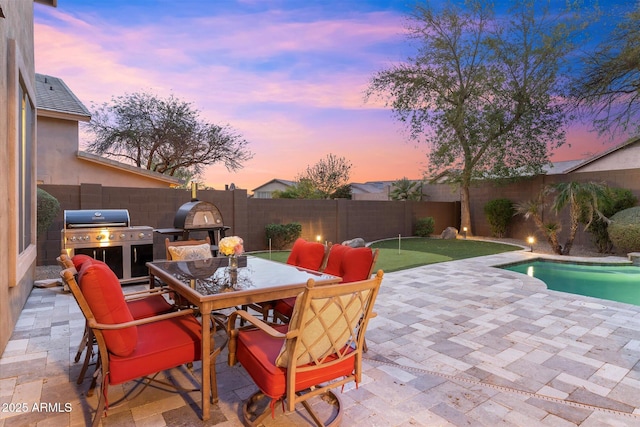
[149,256,336,295]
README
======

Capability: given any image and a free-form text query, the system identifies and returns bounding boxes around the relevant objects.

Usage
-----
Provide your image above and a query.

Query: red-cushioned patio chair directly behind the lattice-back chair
[273,244,379,322]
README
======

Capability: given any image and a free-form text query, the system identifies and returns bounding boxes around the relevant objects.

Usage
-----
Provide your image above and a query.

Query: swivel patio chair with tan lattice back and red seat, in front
[227,270,384,426]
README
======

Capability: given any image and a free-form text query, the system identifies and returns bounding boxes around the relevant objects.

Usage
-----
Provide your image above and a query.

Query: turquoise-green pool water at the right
[502,260,640,305]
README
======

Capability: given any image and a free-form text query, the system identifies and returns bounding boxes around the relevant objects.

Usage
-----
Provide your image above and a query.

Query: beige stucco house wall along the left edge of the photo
[0,0,56,353]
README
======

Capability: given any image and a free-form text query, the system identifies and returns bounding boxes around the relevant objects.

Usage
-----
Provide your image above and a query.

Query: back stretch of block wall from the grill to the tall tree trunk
[38,184,460,265]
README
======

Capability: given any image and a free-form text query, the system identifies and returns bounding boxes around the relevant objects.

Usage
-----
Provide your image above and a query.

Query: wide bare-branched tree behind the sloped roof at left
[87,92,253,176]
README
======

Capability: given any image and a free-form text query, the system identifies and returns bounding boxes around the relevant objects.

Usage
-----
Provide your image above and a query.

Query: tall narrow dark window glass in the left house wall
[17,82,35,254]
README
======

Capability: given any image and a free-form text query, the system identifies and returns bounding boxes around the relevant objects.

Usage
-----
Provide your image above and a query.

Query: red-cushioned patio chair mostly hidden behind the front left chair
[56,254,175,396]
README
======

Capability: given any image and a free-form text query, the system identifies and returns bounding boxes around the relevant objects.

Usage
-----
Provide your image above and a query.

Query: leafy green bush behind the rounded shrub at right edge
[580,188,638,253]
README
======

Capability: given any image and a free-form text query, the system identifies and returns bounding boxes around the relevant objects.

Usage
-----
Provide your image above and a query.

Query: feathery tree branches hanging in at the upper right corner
[572,2,640,136]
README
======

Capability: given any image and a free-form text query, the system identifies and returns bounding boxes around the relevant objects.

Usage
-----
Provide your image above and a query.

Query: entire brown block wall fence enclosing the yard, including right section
[38,168,640,265]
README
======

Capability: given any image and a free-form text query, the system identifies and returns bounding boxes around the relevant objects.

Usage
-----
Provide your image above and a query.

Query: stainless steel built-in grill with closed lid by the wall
[61,209,153,283]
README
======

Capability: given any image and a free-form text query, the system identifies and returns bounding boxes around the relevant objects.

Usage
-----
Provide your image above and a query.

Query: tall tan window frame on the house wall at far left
[7,39,38,287]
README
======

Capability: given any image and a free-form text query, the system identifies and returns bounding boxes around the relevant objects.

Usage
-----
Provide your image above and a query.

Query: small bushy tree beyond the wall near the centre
[297,154,351,199]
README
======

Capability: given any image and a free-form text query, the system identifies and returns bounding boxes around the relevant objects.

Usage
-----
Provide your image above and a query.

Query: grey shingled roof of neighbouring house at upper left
[36,73,91,122]
